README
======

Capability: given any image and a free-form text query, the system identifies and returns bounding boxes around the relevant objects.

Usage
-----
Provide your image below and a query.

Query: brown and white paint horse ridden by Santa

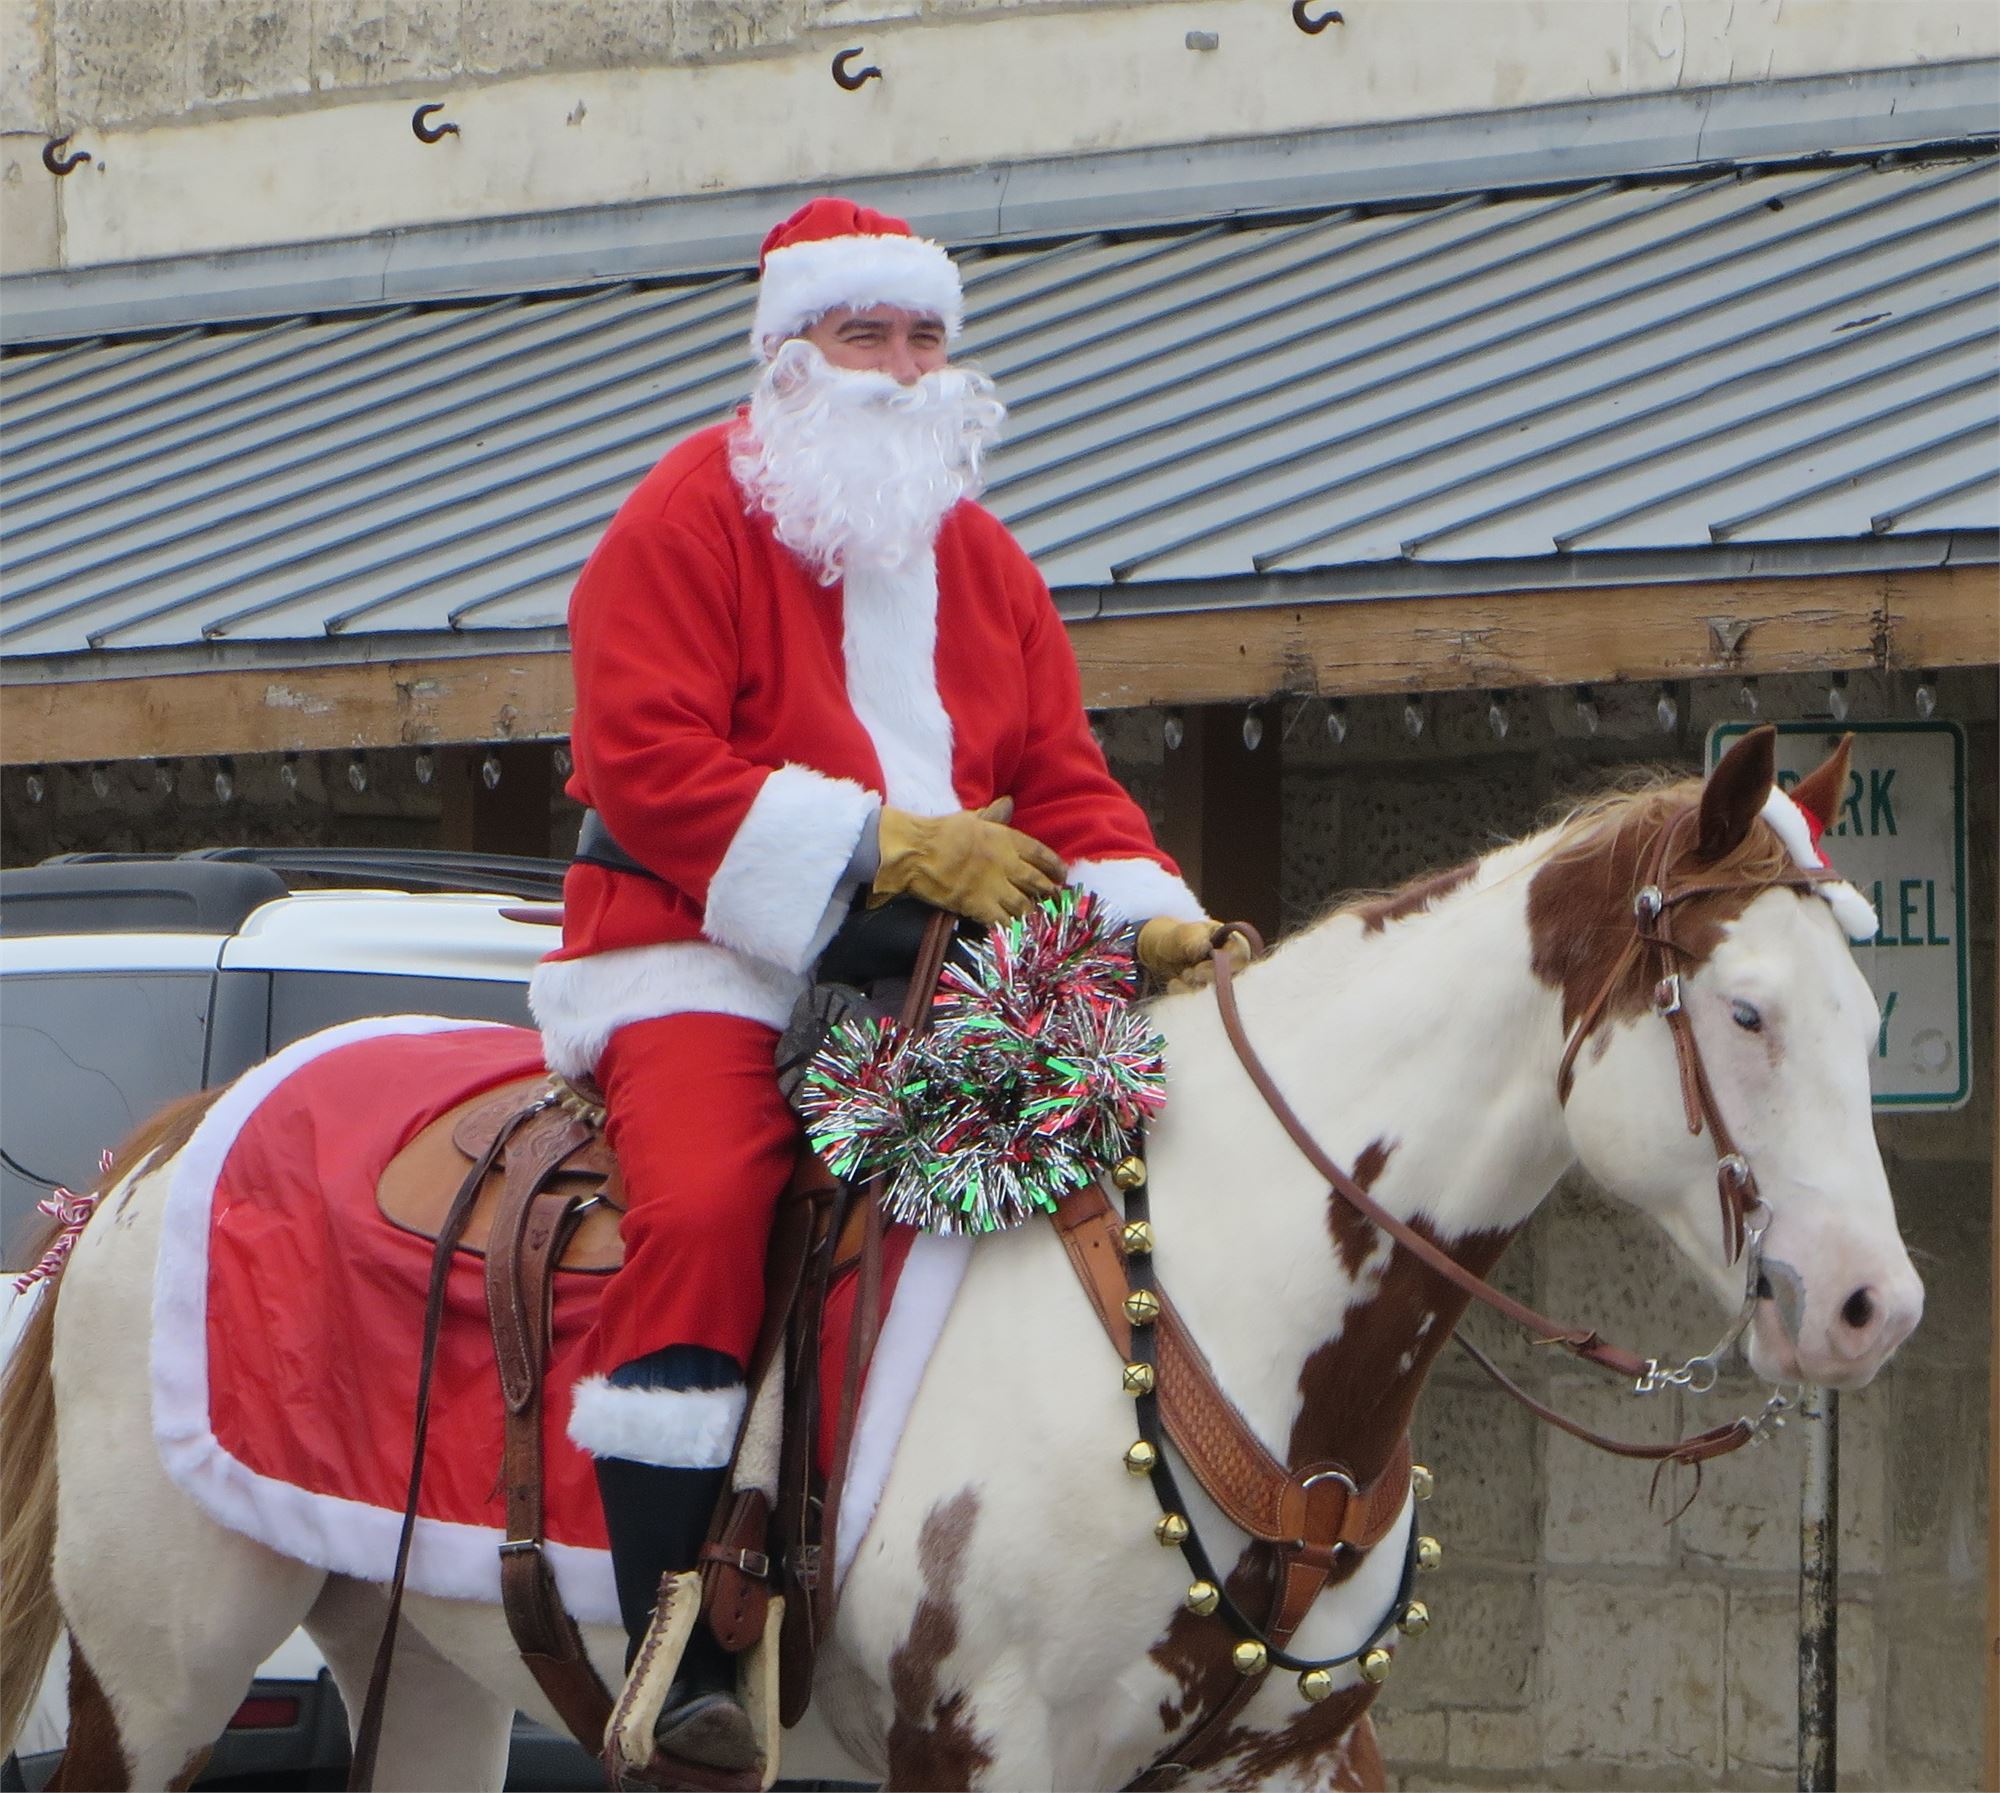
[0,736,1922,1789]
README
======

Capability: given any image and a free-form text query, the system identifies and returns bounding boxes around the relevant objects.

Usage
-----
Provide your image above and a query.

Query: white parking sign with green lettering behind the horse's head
[1708,722,1972,1109]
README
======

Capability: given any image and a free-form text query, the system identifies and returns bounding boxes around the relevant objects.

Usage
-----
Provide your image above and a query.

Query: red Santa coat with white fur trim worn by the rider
[532,424,1202,1075]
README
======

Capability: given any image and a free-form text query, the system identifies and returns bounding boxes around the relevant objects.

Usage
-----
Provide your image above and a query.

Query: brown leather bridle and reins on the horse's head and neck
[1212,808,1838,1465]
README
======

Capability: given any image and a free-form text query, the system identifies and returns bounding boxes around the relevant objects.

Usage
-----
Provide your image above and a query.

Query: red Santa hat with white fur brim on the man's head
[750,198,966,360]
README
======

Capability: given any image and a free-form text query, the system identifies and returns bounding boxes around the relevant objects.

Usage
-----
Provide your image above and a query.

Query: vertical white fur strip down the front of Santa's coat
[840,548,962,816]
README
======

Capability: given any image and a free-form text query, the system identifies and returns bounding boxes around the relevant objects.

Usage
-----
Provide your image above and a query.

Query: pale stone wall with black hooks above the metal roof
[0,0,2000,272]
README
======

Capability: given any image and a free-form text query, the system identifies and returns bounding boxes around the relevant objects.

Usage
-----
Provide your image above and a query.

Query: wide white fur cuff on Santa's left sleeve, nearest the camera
[702,766,878,971]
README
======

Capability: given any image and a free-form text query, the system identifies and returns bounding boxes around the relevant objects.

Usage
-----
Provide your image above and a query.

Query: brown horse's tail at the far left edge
[0,1091,220,1755]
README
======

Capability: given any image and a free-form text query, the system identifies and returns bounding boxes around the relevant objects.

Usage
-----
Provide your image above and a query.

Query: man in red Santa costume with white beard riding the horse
[532,198,1214,1767]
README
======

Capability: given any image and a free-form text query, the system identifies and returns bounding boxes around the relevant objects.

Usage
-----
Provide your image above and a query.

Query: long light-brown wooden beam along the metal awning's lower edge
[0,566,2000,764]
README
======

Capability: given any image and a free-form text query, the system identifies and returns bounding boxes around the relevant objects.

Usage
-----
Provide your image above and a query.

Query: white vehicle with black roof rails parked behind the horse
[0,848,604,1789]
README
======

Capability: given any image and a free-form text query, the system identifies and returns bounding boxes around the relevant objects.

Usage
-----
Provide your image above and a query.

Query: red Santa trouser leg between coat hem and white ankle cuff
[586,1015,798,1375]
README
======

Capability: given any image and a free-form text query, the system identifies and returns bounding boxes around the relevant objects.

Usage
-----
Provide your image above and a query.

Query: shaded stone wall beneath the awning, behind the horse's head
[0,670,2000,1789]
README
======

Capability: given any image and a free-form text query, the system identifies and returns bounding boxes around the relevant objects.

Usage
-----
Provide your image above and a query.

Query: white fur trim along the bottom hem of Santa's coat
[528,941,806,1077]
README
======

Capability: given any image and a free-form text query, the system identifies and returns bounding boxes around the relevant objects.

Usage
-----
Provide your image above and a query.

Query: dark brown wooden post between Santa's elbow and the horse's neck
[1160,704,1284,941]
